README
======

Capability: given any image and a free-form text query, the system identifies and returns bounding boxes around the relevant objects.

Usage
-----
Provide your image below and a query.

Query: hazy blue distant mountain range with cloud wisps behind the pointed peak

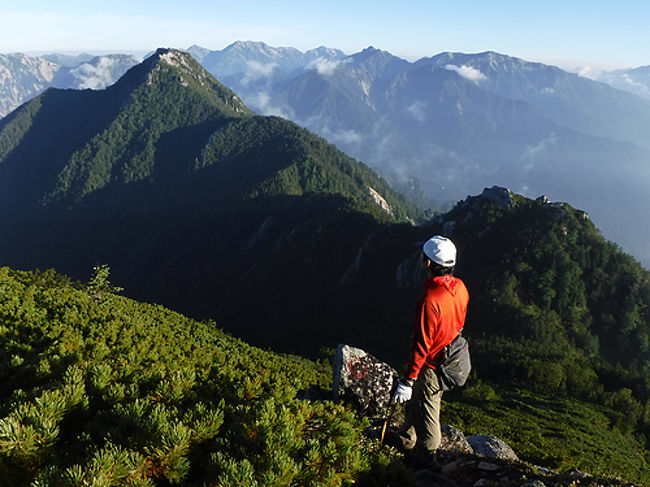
[0,42,650,266]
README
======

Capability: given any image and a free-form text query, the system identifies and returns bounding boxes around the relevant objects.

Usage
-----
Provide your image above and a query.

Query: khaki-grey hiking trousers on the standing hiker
[400,366,442,452]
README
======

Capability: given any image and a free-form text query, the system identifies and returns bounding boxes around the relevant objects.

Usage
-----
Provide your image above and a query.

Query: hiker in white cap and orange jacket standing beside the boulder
[392,235,469,467]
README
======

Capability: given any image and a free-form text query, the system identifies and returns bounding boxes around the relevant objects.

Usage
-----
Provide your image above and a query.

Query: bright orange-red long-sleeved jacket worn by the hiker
[406,276,469,379]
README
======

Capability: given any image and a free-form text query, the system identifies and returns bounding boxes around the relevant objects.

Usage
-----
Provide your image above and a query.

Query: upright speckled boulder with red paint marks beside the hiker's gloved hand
[332,345,399,417]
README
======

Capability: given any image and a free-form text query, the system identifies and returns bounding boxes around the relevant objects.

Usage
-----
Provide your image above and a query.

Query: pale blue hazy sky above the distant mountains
[0,0,650,69]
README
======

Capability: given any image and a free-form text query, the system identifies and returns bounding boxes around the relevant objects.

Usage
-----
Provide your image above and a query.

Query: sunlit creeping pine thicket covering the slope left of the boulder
[0,268,400,487]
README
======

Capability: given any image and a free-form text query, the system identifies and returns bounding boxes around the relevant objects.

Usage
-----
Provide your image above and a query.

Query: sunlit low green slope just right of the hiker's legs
[442,382,650,485]
